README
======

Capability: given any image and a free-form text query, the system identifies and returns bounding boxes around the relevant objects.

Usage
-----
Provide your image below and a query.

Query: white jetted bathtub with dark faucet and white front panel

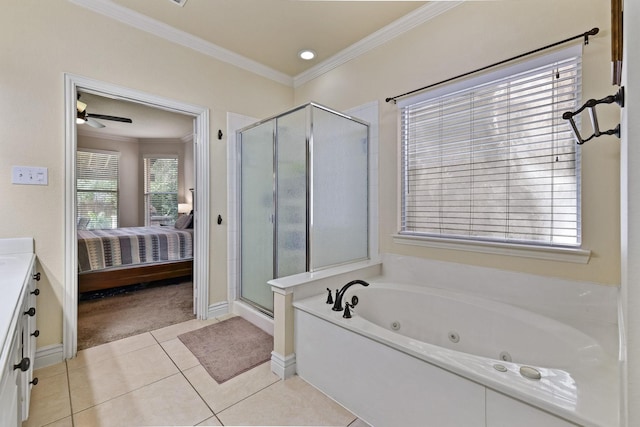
[293,281,620,427]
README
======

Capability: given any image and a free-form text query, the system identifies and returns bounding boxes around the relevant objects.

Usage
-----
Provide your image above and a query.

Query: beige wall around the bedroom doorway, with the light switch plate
[0,0,293,347]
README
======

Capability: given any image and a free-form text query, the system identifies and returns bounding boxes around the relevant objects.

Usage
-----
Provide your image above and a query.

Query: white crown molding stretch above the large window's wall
[293,0,464,88]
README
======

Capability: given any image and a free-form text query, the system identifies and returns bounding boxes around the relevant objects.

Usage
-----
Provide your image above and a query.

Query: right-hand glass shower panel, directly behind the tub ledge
[310,106,369,270]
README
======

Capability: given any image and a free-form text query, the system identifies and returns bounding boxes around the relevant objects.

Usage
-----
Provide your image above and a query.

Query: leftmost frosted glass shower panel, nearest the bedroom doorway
[239,120,275,312]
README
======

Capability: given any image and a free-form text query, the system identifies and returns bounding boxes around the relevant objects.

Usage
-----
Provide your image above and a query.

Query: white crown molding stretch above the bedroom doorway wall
[69,0,293,86]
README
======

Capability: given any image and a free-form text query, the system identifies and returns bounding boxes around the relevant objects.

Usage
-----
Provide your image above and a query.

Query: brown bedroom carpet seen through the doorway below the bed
[78,282,195,350]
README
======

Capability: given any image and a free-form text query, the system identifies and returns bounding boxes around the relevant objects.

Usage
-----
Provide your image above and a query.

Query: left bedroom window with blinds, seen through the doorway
[76,150,119,229]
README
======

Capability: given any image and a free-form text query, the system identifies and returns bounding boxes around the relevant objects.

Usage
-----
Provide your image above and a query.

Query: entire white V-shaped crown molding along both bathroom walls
[69,0,464,88]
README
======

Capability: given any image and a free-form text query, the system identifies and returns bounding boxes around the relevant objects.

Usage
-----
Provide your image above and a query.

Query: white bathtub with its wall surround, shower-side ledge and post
[269,254,624,427]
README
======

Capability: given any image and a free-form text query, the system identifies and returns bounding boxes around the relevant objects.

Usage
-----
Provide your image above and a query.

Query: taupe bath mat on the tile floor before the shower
[178,317,273,384]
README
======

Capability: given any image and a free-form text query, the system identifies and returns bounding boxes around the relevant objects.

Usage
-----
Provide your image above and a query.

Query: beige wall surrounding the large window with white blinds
[295,0,620,284]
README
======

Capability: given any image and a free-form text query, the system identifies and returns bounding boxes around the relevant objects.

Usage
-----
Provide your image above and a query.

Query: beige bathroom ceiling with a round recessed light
[112,0,427,77]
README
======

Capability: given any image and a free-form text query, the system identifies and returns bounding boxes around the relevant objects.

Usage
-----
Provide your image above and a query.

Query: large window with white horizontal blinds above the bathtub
[399,46,581,247]
